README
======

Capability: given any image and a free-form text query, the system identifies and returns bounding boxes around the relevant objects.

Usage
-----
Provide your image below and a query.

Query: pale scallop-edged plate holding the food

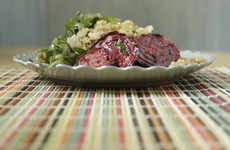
[13,50,215,88]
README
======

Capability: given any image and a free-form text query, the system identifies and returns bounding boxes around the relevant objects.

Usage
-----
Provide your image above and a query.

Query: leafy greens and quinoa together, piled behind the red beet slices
[33,12,153,69]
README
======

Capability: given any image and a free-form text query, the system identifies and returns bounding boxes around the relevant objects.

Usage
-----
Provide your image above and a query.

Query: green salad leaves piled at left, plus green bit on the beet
[33,12,123,73]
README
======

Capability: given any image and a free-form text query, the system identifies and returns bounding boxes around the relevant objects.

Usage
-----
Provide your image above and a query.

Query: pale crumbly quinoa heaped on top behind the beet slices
[67,20,153,50]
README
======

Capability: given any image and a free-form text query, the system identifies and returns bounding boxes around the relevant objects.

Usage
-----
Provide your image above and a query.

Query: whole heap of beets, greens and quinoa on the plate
[33,12,206,69]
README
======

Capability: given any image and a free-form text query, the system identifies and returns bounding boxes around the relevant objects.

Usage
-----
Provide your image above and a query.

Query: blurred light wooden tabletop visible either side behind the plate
[0,47,230,68]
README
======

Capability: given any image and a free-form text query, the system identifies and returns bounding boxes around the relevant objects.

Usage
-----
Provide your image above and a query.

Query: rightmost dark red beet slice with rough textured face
[135,34,180,67]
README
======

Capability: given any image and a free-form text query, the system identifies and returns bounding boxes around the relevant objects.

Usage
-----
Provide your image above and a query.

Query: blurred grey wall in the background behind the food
[0,0,230,51]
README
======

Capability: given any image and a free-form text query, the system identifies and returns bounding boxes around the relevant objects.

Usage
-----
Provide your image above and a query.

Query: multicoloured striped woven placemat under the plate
[0,67,230,150]
